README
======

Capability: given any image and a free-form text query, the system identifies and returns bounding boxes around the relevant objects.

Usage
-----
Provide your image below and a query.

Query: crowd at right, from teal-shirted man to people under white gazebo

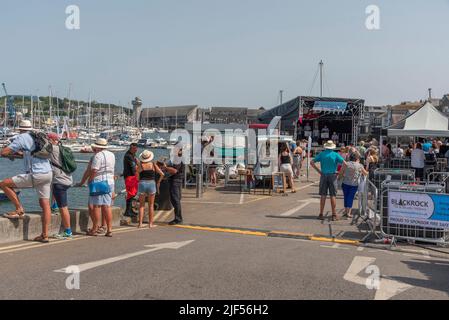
[311,139,449,220]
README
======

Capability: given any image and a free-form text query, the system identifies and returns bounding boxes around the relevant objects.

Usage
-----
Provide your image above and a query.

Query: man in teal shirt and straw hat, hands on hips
[311,141,345,221]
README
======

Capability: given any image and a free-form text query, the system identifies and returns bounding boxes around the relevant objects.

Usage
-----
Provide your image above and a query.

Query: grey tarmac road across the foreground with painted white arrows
[0,222,449,300]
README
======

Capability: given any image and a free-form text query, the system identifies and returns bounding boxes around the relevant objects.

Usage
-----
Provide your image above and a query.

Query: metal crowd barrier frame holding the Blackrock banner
[380,181,449,246]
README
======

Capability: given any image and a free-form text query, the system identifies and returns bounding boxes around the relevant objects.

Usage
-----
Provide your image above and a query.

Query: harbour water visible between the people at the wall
[0,149,169,214]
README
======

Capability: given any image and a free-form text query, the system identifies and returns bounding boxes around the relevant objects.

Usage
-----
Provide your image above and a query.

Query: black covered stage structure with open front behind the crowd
[259,96,365,145]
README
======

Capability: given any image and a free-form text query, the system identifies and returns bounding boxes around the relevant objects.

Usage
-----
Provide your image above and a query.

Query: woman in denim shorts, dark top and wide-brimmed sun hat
[137,150,164,228]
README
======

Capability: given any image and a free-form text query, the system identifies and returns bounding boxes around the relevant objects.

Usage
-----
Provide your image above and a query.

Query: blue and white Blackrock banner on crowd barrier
[388,191,449,229]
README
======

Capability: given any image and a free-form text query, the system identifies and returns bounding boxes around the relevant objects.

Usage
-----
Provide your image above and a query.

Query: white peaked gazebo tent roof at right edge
[387,102,449,137]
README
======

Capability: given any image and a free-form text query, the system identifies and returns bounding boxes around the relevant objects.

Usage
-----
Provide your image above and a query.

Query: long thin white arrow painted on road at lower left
[54,240,195,273]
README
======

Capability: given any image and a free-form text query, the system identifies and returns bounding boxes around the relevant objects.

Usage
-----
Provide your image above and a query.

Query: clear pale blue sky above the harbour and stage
[0,0,449,107]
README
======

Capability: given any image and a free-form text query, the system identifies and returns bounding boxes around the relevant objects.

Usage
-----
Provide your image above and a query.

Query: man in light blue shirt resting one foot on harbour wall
[0,120,53,243]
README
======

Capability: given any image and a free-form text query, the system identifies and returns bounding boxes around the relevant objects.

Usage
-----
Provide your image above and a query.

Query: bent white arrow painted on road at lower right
[343,256,413,300]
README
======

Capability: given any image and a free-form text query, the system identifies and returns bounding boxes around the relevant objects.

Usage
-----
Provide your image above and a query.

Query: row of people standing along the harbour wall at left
[0,120,184,243]
